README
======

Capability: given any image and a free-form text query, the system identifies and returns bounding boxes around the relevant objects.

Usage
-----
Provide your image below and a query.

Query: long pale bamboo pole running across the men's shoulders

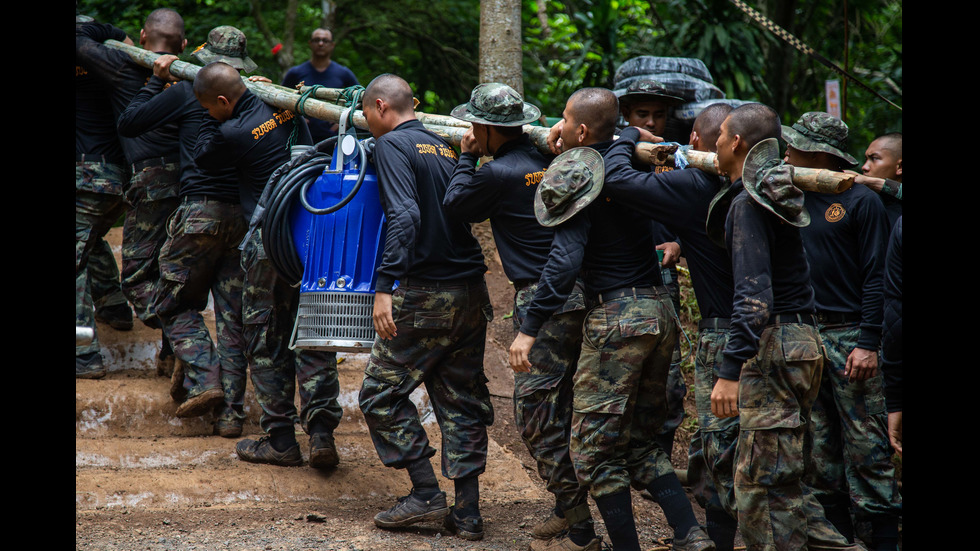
[105,40,854,193]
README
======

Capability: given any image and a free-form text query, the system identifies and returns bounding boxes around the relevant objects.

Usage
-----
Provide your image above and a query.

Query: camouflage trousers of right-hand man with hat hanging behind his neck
[735,323,847,551]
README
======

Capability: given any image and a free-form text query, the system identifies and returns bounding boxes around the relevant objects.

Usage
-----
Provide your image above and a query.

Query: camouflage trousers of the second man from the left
[122,159,180,329]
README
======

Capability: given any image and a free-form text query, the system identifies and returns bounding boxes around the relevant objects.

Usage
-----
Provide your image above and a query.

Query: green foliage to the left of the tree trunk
[78,0,480,114]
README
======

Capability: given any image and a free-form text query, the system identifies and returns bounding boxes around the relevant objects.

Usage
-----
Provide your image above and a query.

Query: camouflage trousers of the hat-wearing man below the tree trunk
[514,282,588,511]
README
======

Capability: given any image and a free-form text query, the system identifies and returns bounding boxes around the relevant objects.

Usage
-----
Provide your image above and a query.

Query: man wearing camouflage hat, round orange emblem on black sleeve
[782,112,901,551]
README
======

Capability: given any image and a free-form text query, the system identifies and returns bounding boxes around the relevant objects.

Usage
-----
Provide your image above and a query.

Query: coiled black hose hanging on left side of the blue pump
[253,136,337,286]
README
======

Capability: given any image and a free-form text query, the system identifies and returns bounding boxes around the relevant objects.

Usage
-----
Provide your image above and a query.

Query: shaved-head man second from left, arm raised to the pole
[75,8,187,375]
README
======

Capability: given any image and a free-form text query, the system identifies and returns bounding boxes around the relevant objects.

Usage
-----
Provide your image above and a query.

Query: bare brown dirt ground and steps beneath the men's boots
[75,225,720,551]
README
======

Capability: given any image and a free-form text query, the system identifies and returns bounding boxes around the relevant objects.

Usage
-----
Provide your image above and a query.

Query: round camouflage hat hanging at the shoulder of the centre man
[534,147,606,226]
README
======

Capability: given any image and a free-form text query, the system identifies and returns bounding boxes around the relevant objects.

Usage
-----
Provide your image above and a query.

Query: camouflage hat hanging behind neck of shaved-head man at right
[742,138,810,228]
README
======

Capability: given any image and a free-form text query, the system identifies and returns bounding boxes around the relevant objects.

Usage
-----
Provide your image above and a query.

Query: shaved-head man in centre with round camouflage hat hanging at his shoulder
[510,88,714,551]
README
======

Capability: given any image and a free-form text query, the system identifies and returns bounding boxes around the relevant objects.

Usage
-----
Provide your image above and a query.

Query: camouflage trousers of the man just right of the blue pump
[359,275,493,479]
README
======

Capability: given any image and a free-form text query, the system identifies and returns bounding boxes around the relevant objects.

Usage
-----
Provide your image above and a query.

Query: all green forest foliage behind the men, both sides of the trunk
[77,0,902,142]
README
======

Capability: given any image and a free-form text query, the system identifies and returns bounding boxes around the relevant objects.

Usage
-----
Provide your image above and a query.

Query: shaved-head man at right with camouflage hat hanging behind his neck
[708,103,856,551]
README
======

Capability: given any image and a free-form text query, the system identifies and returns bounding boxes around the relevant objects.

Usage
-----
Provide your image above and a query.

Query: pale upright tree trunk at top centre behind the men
[480,0,524,96]
